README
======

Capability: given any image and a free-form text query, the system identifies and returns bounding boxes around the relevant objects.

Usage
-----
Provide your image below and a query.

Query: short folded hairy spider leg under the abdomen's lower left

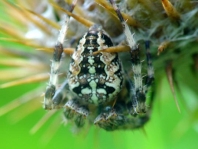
[64,99,89,127]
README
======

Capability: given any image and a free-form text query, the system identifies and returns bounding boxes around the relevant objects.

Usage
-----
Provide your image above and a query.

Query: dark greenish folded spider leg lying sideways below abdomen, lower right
[94,102,150,131]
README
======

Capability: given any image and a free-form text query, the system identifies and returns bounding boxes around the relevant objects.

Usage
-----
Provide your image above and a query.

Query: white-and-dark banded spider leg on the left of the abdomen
[43,0,77,110]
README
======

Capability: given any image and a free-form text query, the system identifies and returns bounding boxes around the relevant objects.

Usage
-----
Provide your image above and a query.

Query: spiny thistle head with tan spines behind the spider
[0,0,198,148]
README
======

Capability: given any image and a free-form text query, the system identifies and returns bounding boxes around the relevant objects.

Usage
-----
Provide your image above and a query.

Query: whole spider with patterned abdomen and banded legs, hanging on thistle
[44,0,154,130]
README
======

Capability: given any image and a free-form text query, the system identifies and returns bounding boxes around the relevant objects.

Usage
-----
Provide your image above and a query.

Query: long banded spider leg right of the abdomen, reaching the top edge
[109,0,146,115]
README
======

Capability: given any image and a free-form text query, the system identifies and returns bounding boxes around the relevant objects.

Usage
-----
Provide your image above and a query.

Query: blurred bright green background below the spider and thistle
[0,78,198,149]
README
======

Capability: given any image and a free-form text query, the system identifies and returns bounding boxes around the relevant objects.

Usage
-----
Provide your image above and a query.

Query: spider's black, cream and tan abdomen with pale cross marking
[68,26,123,104]
